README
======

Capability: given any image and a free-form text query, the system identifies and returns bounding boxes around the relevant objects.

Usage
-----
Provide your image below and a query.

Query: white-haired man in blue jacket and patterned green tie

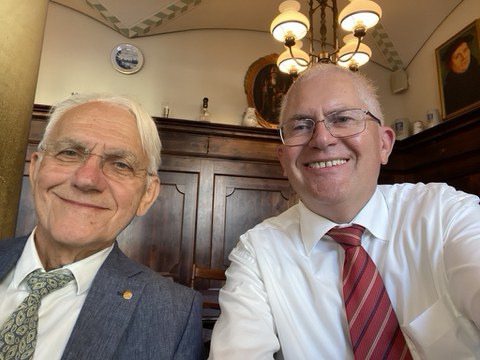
[0,95,202,360]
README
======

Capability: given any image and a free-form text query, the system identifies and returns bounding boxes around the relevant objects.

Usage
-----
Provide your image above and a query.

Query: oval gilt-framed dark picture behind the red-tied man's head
[244,54,293,128]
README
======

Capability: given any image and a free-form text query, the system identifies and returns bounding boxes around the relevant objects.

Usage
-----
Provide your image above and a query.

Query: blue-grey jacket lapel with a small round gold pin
[62,244,145,360]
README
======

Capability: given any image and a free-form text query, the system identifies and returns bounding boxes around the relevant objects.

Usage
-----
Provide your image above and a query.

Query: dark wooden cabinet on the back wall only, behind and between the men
[17,106,297,285]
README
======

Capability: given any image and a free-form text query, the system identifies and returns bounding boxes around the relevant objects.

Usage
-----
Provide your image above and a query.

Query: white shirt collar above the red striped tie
[299,187,390,255]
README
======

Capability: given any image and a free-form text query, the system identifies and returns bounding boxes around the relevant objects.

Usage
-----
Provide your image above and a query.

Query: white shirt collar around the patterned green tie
[13,229,114,295]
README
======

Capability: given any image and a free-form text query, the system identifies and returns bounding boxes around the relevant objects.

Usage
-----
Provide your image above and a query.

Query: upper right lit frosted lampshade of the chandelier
[338,0,382,31]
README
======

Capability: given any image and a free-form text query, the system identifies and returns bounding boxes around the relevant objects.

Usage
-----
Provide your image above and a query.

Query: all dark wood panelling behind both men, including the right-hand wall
[17,106,480,285]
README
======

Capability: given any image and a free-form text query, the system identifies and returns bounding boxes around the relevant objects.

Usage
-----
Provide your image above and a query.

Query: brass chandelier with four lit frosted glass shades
[270,0,382,75]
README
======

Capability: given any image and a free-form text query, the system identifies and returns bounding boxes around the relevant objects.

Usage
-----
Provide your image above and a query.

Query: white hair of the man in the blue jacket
[38,93,162,174]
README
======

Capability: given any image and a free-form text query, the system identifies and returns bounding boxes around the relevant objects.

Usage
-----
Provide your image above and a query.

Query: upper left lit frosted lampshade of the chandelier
[270,0,310,42]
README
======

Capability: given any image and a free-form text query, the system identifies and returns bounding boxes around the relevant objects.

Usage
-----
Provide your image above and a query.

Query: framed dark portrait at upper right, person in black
[435,19,480,120]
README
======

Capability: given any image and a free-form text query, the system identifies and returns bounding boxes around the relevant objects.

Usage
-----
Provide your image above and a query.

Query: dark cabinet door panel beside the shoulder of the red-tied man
[211,175,297,267]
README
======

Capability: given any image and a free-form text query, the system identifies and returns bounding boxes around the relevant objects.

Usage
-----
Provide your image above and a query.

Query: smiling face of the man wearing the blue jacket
[30,102,159,267]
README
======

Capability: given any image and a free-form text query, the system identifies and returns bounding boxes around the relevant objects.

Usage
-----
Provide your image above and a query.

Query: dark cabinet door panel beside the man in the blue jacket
[118,171,198,285]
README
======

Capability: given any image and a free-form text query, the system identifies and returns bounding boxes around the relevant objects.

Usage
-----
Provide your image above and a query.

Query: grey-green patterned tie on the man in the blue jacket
[0,270,73,360]
